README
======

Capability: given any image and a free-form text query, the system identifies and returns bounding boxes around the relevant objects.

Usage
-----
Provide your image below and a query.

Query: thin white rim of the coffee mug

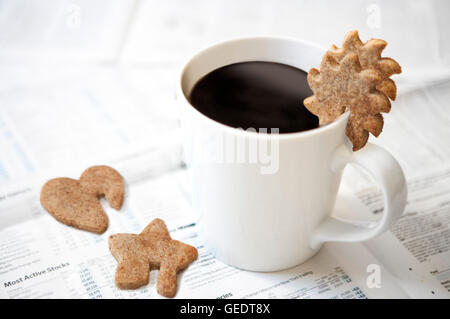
[176,36,350,140]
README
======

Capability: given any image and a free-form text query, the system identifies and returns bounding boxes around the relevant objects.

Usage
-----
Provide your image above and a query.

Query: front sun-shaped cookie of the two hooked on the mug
[304,53,390,151]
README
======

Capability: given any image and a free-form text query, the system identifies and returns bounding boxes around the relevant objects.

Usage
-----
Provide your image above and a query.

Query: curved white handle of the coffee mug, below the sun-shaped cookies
[310,143,407,249]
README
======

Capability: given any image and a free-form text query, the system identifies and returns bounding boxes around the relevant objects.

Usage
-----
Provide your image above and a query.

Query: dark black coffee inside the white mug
[190,62,319,133]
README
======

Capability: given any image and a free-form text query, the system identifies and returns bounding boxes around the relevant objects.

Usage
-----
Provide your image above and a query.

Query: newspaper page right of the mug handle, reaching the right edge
[343,80,450,298]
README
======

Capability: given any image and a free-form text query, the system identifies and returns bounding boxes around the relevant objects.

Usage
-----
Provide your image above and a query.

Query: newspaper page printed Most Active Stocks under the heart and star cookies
[0,169,408,298]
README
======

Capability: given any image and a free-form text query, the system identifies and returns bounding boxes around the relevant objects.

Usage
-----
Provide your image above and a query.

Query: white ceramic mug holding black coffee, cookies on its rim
[177,37,407,271]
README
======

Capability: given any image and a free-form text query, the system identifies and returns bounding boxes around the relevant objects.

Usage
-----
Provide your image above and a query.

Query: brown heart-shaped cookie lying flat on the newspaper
[41,166,124,234]
